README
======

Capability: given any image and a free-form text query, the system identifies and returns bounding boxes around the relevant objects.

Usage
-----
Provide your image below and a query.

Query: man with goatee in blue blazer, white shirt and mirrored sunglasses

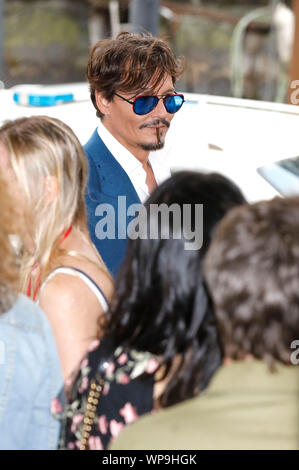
[84,32,184,275]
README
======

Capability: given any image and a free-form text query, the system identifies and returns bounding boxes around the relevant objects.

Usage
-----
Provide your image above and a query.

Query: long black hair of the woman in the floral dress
[106,172,245,406]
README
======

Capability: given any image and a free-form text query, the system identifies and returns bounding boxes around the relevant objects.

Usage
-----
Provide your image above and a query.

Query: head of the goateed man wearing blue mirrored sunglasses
[87,32,184,156]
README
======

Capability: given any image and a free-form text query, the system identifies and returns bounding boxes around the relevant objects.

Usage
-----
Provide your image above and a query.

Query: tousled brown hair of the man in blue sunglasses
[87,32,184,117]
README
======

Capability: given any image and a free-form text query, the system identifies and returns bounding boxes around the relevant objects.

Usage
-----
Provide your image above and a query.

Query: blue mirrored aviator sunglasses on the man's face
[114,93,185,115]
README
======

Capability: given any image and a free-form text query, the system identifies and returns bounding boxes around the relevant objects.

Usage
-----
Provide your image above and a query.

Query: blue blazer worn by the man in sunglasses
[83,129,141,276]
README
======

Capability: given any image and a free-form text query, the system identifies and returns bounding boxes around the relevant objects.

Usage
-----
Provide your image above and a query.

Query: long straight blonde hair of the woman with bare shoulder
[0,116,87,291]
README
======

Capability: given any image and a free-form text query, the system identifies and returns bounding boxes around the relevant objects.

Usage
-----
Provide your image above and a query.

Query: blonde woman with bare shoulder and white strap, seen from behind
[0,116,113,385]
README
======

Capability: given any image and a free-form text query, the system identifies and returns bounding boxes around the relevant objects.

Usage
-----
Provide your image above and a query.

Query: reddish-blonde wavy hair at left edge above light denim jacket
[0,172,18,314]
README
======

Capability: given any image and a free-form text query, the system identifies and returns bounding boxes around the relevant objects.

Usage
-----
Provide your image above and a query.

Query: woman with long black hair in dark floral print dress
[55,172,244,449]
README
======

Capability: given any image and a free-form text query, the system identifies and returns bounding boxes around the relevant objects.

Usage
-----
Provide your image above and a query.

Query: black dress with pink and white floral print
[52,340,159,450]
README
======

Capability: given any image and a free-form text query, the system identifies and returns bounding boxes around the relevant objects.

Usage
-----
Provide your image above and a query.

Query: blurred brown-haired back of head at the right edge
[205,198,299,365]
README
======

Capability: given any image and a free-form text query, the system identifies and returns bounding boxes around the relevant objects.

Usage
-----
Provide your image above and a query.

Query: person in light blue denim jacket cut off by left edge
[0,171,63,450]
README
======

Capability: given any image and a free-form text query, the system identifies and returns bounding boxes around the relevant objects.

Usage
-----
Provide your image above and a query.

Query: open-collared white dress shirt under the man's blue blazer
[98,121,171,203]
